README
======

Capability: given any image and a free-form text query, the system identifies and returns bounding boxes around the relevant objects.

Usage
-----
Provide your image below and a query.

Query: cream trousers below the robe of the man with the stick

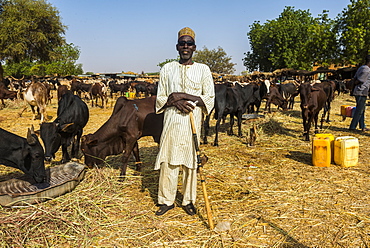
[158,163,197,206]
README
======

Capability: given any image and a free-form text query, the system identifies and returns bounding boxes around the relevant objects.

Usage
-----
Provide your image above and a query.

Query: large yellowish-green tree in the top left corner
[0,0,66,80]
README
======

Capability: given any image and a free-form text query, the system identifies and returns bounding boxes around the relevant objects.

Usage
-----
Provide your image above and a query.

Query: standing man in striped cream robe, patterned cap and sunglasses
[154,27,215,215]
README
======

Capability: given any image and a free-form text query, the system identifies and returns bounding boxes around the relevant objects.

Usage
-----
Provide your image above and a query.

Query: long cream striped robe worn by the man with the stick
[154,61,215,170]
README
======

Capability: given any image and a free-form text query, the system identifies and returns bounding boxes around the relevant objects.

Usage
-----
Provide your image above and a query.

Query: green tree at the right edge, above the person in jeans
[336,0,370,64]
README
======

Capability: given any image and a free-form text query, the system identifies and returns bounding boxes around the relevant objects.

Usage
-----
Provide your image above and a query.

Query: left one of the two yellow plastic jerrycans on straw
[312,137,332,167]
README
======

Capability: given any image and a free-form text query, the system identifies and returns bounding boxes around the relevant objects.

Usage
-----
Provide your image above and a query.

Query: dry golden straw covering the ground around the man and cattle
[0,91,370,247]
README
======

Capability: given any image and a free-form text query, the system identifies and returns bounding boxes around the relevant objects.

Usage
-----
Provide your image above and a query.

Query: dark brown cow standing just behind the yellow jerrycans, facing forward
[299,83,327,141]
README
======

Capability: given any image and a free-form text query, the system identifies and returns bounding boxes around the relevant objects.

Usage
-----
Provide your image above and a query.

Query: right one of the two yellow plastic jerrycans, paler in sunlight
[334,136,359,167]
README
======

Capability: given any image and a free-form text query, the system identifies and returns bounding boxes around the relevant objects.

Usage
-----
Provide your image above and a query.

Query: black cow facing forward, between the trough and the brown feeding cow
[40,91,89,163]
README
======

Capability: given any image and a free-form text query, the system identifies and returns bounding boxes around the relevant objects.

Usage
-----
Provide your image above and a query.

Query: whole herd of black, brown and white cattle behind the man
[0,76,353,183]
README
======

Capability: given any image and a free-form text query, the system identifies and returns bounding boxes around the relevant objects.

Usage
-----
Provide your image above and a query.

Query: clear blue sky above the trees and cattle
[48,0,350,75]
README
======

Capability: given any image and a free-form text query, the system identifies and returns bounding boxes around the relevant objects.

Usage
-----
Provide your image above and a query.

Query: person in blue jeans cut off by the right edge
[349,55,370,131]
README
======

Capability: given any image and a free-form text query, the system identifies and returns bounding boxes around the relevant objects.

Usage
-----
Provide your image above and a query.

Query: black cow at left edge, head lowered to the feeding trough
[0,126,46,183]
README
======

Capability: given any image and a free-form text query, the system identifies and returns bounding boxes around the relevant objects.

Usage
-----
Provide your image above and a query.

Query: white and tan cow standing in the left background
[19,82,48,123]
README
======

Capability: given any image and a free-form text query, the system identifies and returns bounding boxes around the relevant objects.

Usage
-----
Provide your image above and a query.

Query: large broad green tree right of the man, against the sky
[244,6,315,71]
